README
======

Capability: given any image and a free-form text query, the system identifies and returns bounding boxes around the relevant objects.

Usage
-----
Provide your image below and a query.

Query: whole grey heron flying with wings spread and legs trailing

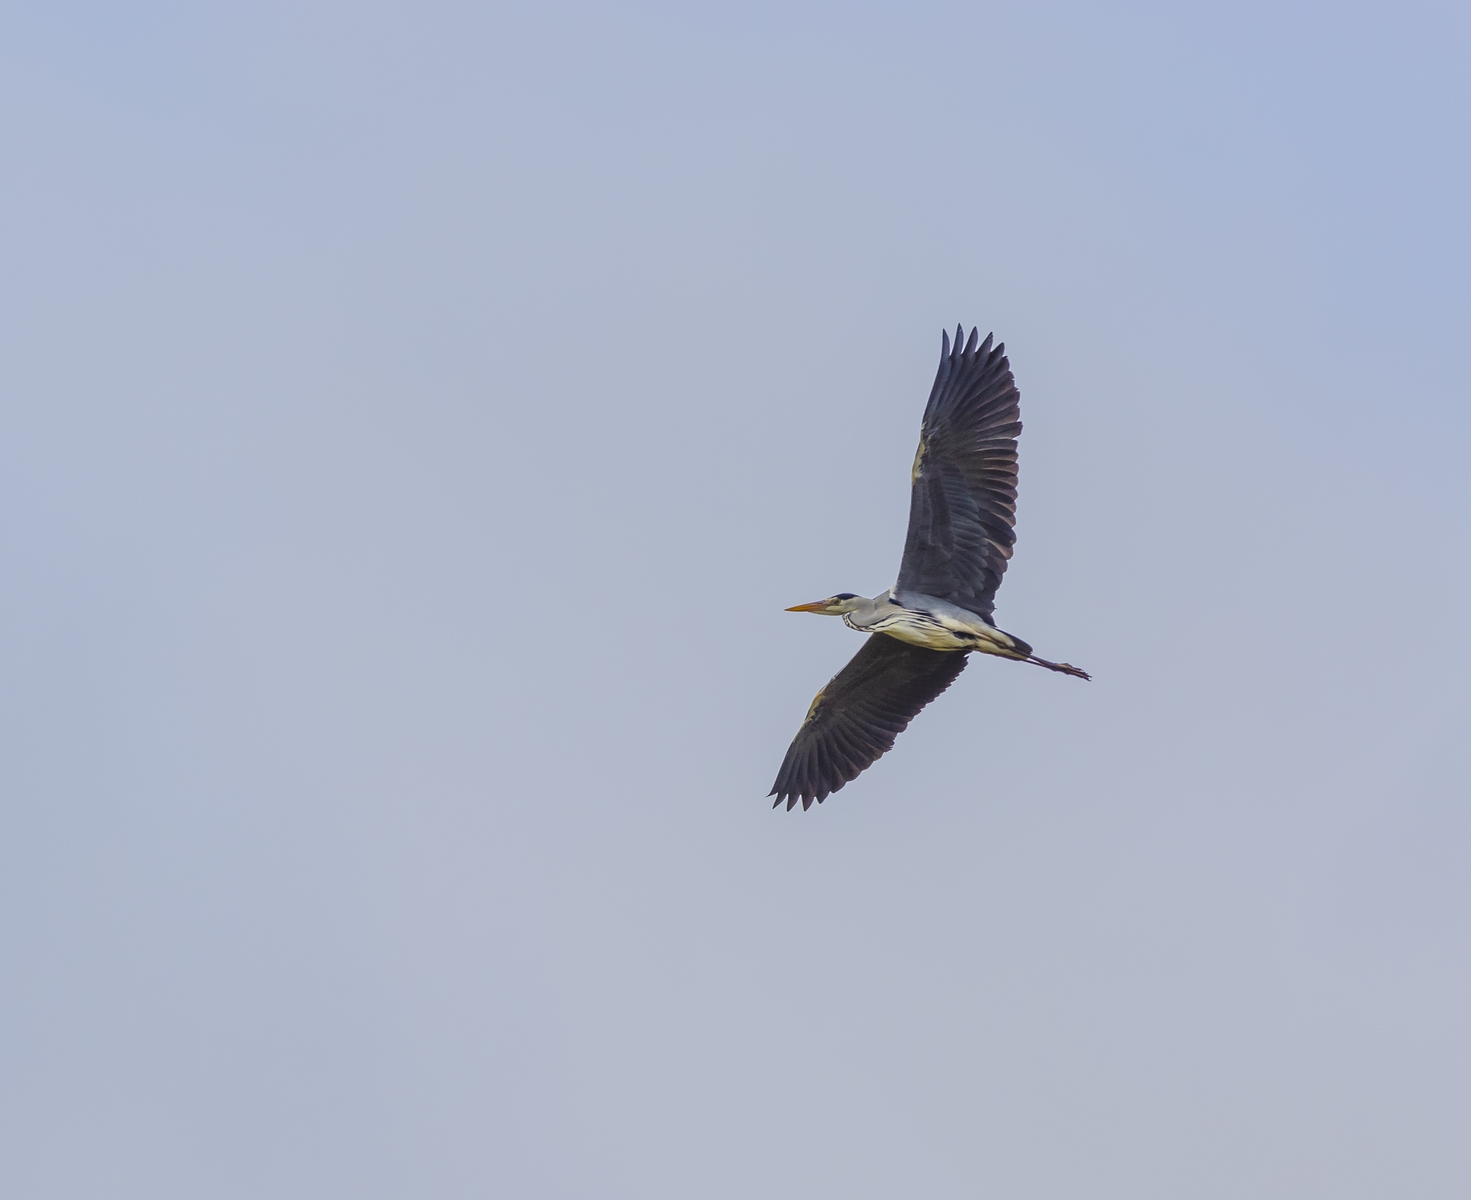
[769,326,1089,812]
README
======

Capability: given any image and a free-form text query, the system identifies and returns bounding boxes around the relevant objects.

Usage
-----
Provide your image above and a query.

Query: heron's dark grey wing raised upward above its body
[897,326,1021,621]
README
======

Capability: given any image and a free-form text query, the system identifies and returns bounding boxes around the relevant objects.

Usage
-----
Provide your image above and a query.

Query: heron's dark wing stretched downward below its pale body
[769,634,966,812]
